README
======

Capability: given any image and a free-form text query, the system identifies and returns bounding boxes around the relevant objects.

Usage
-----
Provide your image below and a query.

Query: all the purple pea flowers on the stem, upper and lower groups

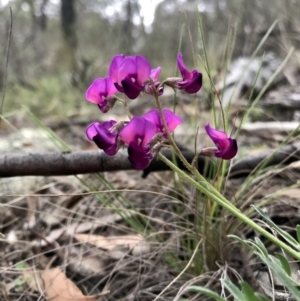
[86,53,237,169]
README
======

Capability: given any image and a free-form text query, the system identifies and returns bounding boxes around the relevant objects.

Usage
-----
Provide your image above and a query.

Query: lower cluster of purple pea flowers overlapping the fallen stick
[86,109,182,169]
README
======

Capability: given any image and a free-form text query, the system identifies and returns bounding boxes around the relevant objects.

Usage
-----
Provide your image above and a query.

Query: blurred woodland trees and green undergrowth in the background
[0,0,300,117]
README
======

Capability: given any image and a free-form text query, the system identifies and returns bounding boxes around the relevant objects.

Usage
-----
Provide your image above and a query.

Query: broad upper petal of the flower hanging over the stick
[120,116,156,146]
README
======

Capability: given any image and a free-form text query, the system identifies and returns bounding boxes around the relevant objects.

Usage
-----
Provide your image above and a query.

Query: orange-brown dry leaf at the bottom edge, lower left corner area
[41,268,97,301]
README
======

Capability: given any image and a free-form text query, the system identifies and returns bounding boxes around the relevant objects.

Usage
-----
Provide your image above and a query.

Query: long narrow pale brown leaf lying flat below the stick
[74,234,144,250]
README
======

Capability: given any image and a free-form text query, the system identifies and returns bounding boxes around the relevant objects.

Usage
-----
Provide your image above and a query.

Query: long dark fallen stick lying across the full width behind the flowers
[0,142,300,178]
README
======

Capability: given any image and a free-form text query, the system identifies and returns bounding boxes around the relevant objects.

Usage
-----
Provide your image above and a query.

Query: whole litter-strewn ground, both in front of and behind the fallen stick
[0,71,300,301]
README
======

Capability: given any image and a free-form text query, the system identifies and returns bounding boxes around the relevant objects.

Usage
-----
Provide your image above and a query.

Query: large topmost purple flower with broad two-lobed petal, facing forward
[109,54,151,99]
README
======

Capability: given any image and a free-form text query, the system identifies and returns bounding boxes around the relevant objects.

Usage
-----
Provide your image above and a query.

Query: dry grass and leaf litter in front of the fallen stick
[0,79,300,301]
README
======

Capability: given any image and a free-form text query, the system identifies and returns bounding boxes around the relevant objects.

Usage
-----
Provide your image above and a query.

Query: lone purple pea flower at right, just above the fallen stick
[205,124,238,160]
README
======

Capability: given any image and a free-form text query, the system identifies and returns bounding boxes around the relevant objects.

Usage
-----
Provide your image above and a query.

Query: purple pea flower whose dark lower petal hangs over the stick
[120,116,157,169]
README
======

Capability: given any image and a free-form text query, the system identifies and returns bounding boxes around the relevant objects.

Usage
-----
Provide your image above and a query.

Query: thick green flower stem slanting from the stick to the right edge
[159,154,300,260]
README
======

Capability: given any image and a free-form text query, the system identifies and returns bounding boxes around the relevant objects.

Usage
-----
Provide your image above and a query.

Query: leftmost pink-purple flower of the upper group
[86,76,118,113]
